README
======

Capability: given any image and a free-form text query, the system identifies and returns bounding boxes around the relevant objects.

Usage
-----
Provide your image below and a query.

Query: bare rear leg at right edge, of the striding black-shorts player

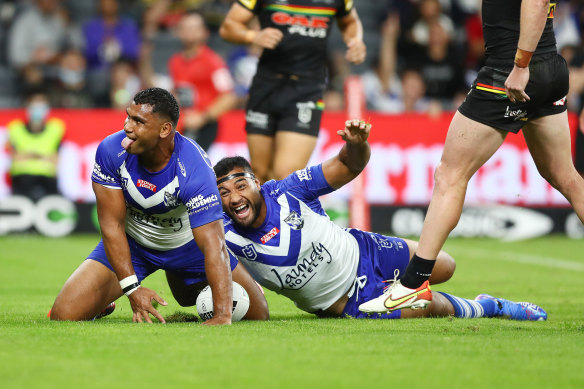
[523,112,584,223]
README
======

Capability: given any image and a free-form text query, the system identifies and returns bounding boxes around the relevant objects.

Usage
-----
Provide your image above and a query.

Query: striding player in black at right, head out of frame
[360,0,584,312]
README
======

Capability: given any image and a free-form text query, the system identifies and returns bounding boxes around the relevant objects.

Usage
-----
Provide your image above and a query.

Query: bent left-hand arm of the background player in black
[219,3,284,49]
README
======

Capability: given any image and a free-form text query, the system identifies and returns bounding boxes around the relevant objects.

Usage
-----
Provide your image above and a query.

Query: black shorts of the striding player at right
[458,53,569,133]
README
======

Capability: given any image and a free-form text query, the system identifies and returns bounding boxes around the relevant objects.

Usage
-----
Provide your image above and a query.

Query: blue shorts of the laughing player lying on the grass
[343,229,410,319]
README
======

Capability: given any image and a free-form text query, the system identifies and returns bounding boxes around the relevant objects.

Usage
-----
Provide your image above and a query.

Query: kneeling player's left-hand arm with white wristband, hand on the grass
[93,182,166,323]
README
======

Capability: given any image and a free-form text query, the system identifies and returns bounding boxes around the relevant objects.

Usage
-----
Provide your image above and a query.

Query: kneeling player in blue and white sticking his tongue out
[50,88,268,325]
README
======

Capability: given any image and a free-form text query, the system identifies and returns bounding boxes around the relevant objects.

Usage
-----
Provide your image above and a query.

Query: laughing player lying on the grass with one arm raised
[214,120,547,320]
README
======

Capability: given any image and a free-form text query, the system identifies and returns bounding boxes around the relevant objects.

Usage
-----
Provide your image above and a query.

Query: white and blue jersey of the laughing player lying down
[225,165,359,312]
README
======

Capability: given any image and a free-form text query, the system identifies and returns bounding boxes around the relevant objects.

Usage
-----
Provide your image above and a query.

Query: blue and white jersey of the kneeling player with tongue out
[91,131,222,252]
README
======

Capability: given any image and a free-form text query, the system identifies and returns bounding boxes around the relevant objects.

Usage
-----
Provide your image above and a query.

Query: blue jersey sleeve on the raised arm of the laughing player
[277,164,334,202]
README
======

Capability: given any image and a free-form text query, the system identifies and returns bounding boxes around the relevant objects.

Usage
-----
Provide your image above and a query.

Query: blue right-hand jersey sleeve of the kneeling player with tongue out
[179,146,223,228]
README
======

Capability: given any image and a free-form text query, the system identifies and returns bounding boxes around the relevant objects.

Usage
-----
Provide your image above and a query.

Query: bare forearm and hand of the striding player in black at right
[505,0,550,103]
